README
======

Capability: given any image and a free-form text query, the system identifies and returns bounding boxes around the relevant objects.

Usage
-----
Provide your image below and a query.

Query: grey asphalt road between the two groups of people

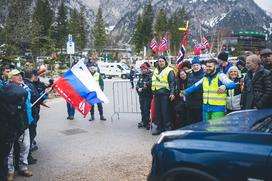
[15,79,157,181]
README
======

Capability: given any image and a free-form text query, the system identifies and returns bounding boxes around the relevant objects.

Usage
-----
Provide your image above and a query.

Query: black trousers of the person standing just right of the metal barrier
[139,95,152,125]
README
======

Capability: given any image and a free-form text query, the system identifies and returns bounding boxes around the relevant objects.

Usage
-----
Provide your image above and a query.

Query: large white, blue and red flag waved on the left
[52,61,109,117]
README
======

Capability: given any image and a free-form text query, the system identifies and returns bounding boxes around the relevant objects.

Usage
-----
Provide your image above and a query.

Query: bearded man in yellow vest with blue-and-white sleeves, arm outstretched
[182,59,236,122]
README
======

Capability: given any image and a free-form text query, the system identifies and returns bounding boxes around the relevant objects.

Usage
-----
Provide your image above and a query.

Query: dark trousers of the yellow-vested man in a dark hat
[154,95,172,131]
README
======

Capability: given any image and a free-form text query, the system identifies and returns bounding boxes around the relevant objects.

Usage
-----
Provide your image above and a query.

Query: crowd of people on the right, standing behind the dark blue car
[136,49,272,135]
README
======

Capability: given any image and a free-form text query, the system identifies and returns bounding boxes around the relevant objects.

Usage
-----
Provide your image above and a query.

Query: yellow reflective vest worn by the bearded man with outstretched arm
[203,75,227,106]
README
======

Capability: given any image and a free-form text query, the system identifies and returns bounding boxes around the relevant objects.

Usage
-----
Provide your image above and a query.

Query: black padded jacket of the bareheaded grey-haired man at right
[241,65,272,109]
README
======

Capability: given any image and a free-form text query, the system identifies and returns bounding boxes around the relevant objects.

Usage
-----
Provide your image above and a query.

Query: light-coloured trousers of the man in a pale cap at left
[8,129,30,174]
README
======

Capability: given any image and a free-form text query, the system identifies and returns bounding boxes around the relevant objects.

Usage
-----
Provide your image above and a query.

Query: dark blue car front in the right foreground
[148,109,272,181]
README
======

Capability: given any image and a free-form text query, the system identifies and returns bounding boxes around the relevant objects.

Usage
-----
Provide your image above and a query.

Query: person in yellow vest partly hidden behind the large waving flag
[89,64,107,121]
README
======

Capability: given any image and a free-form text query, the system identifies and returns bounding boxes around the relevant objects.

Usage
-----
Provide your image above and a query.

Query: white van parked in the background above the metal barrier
[98,62,130,79]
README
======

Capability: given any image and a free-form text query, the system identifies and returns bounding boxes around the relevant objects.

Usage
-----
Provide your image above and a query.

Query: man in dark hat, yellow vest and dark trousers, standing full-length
[151,56,175,135]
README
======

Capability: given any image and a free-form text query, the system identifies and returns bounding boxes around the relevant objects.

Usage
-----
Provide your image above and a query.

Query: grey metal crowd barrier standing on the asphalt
[111,80,141,120]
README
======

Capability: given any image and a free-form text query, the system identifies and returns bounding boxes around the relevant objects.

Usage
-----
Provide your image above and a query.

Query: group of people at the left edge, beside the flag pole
[0,65,52,181]
